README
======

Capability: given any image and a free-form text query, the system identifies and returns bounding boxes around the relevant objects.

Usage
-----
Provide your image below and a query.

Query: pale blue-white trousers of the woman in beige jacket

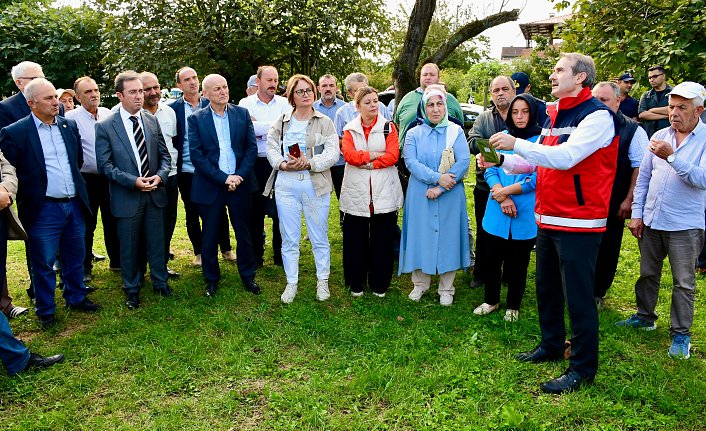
[275,171,331,284]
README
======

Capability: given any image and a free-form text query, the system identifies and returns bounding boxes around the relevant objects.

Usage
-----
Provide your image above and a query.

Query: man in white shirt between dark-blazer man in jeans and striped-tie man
[66,76,120,283]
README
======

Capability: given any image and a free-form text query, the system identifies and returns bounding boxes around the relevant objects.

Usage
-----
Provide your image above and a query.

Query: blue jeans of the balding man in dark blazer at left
[27,198,86,316]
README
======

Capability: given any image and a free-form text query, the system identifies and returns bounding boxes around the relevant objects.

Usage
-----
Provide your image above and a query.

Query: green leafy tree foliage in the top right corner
[557,0,706,88]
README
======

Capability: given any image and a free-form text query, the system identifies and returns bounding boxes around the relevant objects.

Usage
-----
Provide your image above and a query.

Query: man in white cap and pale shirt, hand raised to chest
[616,82,706,359]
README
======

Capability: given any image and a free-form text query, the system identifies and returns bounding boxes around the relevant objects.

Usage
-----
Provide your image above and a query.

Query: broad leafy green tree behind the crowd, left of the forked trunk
[94,0,387,97]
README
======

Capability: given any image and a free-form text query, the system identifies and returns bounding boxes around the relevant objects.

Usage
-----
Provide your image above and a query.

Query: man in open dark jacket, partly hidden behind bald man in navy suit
[167,67,236,266]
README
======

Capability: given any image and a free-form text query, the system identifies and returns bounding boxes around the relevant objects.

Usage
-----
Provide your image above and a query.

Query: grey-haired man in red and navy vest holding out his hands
[490,53,618,394]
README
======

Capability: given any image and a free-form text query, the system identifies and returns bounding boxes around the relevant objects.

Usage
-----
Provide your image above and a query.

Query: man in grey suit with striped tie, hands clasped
[96,71,172,309]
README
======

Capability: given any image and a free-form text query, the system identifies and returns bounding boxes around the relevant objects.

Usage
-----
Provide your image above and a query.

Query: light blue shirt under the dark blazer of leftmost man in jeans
[32,113,76,198]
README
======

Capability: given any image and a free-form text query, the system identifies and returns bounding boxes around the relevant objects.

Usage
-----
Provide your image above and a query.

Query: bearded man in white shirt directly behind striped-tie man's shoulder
[140,72,179,278]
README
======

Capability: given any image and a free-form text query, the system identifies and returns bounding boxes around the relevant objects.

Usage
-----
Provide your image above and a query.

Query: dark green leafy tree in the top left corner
[0,1,107,96]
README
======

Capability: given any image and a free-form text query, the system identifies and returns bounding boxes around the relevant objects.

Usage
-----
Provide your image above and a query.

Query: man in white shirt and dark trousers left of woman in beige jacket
[238,66,292,266]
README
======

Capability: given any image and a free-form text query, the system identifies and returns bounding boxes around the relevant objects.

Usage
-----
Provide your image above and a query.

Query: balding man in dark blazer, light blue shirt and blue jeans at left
[0,78,99,327]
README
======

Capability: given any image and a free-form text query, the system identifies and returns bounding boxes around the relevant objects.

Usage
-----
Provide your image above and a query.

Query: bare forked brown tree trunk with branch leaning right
[393,0,520,109]
